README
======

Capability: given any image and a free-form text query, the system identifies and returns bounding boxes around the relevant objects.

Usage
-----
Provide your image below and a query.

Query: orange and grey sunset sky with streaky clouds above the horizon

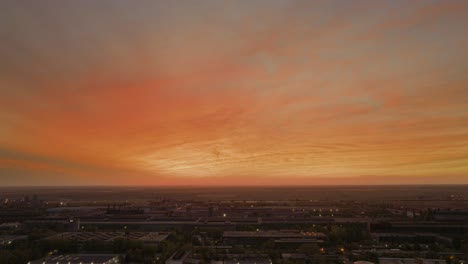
[0,0,468,186]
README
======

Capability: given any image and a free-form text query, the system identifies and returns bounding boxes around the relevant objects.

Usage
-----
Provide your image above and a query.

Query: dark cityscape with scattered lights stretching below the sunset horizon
[0,185,468,264]
